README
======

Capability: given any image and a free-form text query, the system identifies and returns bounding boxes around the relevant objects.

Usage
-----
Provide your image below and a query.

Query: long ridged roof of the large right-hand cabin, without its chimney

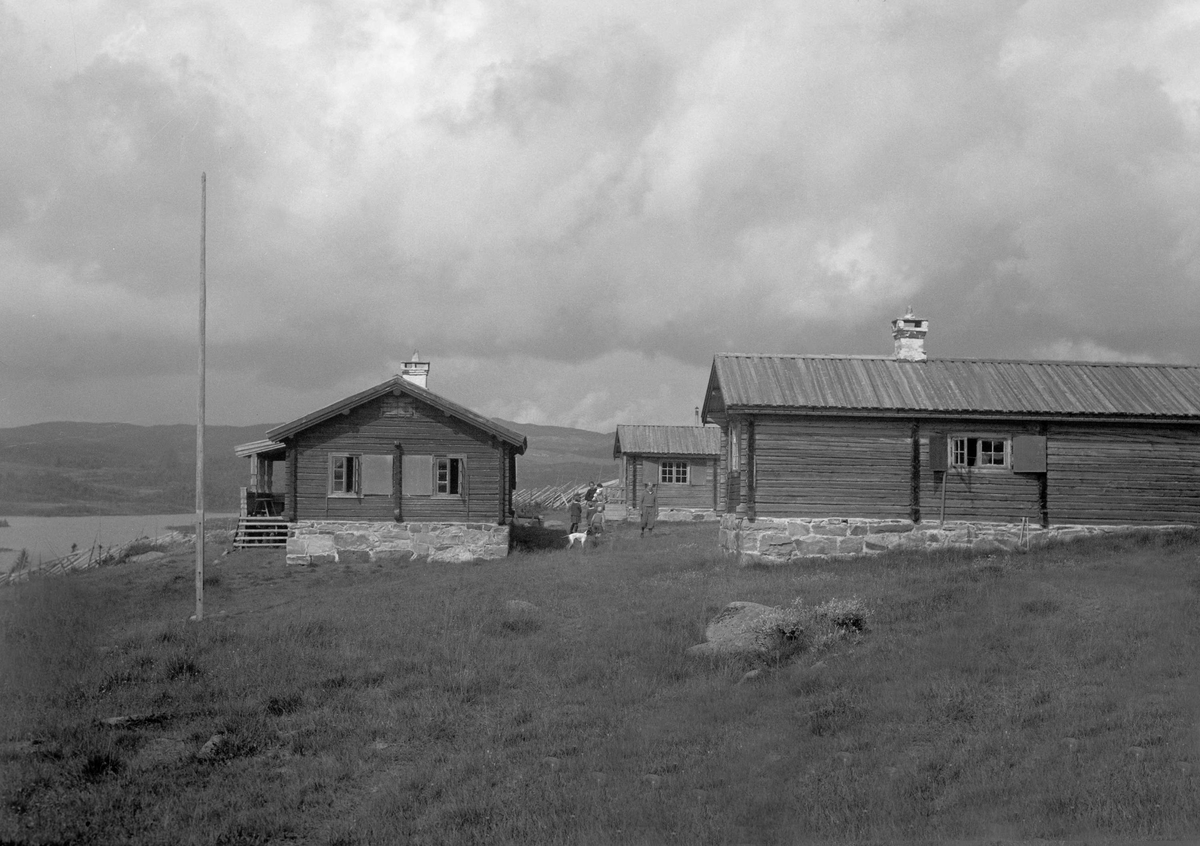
[706,354,1200,419]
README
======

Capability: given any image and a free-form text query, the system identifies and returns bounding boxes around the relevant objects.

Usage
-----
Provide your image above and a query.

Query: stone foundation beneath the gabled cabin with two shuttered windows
[288,521,509,564]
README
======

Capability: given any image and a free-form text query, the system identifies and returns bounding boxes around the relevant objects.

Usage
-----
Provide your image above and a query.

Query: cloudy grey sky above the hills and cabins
[0,0,1200,431]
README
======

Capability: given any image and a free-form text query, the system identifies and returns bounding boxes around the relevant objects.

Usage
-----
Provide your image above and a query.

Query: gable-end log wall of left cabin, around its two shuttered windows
[289,397,511,523]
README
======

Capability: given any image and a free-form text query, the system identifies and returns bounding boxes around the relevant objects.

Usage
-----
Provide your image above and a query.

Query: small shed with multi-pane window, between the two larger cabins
[612,425,721,514]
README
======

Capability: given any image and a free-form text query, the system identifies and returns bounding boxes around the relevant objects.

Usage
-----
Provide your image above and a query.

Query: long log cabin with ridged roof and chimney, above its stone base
[702,310,1200,561]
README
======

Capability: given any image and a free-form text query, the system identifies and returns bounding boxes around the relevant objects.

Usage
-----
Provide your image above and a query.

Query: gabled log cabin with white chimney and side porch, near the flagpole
[238,356,527,559]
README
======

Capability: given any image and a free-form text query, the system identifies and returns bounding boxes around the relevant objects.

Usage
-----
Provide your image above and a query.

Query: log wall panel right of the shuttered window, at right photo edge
[1046,424,1200,524]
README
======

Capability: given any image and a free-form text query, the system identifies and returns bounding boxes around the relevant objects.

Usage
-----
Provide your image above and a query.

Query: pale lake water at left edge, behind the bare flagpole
[0,511,238,572]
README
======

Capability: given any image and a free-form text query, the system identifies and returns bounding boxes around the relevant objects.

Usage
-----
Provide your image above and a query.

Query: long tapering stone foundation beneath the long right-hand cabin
[720,514,1194,565]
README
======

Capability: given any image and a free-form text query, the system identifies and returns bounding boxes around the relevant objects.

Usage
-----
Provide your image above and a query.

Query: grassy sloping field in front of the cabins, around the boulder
[0,524,1200,845]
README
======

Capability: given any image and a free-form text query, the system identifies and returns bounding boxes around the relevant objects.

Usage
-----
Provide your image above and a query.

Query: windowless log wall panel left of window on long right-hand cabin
[752,415,912,518]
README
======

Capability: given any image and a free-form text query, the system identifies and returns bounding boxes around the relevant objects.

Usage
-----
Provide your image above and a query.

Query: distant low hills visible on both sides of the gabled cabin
[0,420,618,517]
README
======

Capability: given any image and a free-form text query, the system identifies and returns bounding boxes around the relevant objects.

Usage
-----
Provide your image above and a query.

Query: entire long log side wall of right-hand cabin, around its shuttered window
[748,415,1200,524]
